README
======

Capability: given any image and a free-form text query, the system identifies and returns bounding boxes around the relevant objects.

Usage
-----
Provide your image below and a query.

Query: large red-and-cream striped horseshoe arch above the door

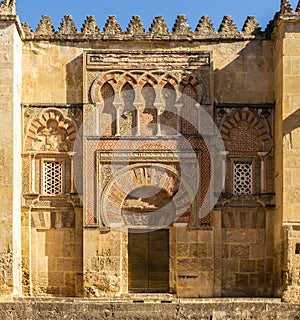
[99,163,191,227]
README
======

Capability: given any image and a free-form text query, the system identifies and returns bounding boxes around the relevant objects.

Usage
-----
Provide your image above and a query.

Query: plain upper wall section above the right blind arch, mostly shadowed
[213,40,274,104]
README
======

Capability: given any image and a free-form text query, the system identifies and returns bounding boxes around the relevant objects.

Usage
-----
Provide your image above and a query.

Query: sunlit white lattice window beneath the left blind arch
[43,161,62,195]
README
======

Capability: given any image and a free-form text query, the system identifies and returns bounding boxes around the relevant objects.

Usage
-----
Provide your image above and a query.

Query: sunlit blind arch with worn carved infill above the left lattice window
[25,108,77,151]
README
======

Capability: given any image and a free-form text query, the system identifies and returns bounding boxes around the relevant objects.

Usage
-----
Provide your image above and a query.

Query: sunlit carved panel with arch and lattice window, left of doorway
[23,106,82,228]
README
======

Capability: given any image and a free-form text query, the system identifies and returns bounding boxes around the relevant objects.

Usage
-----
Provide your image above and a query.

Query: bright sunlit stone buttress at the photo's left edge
[0,17,22,296]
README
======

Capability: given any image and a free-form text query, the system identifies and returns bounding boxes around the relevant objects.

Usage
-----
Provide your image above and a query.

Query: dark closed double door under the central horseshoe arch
[128,229,169,292]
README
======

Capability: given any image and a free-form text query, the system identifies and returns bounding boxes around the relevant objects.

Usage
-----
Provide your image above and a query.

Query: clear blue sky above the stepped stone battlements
[17,0,298,30]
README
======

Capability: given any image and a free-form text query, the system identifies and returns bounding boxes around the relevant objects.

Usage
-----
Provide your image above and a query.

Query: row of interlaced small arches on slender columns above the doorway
[90,71,207,136]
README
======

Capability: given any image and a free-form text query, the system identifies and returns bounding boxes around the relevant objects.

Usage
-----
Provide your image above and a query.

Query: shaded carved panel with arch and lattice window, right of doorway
[216,105,274,206]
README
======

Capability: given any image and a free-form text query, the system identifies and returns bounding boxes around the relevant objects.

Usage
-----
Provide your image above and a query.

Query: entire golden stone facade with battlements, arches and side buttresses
[0,1,300,310]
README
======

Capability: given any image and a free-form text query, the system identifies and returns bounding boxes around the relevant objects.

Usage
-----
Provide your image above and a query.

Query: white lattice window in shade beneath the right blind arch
[233,162,252,195]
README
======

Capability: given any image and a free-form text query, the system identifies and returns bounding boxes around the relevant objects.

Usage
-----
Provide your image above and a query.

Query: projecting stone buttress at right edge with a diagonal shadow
[274,19,300,300]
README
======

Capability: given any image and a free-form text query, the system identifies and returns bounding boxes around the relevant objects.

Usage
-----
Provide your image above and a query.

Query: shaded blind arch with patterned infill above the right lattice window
[220,110,273,152]
